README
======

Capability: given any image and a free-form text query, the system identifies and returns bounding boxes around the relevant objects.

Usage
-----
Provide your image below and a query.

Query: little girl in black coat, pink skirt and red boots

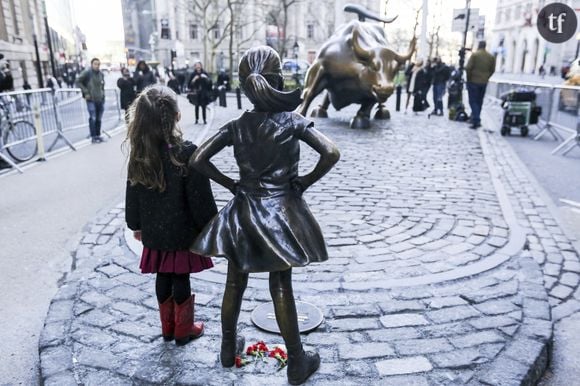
[125,86,217,346]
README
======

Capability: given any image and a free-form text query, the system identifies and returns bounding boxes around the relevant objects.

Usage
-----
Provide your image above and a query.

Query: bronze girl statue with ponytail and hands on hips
[190,47,339,385]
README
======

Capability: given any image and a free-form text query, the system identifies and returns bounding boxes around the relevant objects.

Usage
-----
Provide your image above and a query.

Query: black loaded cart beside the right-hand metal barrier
[500,90,542,137]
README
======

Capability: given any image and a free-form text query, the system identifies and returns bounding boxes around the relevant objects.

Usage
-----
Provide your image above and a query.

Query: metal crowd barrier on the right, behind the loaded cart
[486,80,580,155]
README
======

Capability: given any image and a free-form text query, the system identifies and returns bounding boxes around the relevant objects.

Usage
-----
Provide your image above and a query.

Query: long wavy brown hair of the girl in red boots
[125,86,186,192]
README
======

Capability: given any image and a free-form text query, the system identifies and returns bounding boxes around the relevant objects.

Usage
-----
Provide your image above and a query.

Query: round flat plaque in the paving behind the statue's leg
[251,302,324,334]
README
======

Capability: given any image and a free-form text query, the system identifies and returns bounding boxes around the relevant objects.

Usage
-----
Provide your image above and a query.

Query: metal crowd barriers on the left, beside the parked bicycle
[0,88,123,171]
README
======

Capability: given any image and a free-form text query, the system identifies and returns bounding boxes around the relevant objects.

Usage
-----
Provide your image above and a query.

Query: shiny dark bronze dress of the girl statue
[191,111,328,272]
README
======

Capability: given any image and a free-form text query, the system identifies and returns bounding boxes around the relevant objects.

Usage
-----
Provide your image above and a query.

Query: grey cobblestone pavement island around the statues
[40,100,580,385]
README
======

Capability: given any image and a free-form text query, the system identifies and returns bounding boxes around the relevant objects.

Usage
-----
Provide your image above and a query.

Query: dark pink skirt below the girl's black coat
[139,247,213,274]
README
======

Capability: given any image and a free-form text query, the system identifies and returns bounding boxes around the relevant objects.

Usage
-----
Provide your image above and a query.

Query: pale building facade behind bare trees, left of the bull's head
[122,0,380,72]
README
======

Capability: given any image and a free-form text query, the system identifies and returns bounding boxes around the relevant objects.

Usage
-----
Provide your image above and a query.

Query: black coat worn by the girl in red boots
[125,142,217,251]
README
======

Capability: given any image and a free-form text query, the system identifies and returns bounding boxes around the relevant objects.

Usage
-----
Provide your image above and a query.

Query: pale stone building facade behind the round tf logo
[490,0,580,75]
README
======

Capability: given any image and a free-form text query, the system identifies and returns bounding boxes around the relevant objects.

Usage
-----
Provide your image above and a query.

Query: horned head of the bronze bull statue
[352,28,417,103]
